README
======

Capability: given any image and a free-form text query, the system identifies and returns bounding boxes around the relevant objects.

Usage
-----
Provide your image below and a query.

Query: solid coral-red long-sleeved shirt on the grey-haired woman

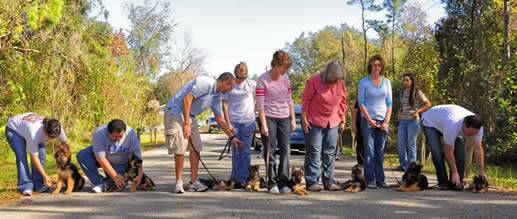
[302,74,346,128]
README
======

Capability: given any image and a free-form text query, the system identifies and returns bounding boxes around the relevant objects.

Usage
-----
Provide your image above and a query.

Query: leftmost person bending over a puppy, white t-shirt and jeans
[5,113,69,196]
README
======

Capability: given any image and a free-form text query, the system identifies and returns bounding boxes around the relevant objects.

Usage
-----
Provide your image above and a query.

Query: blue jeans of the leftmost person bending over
[5,127,46,192]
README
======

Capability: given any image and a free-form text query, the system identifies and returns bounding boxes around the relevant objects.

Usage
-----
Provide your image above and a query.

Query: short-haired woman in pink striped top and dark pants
[255,50,296,194]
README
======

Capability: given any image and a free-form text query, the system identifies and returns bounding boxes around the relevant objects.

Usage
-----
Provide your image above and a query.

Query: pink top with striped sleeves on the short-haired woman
[255,72,293,118]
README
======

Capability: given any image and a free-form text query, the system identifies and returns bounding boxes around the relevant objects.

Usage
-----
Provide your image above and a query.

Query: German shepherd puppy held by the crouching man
[106,154,156,192]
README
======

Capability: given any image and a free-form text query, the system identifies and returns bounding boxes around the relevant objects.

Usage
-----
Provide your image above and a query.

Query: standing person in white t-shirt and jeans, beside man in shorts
[222,62,257,186]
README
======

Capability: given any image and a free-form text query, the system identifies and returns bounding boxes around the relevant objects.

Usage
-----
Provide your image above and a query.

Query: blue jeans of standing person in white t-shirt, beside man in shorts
[231,121,257,184]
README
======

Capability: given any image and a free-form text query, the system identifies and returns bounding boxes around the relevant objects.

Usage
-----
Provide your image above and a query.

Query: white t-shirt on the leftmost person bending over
[7,113,67,155]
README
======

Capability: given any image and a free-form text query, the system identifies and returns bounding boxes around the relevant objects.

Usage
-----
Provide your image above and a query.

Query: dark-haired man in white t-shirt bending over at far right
[422,104,486,190]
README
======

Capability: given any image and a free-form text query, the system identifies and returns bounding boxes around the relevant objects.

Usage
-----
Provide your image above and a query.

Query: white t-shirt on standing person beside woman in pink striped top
[222,79,257,123]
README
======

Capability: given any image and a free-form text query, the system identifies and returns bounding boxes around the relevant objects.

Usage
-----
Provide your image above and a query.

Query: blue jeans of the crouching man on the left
[76,146,128,185]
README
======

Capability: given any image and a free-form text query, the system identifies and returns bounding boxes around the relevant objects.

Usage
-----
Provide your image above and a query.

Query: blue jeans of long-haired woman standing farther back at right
[397,119,420,170]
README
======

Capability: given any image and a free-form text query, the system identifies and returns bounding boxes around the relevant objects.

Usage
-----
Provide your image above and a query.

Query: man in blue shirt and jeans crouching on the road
[77,119,144,193]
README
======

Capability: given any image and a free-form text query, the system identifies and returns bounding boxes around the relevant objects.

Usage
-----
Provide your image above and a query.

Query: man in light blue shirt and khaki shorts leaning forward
[164,72,243,193]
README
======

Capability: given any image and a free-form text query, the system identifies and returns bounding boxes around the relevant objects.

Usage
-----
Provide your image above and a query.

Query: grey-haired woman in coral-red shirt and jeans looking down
[302,60,346,191]
